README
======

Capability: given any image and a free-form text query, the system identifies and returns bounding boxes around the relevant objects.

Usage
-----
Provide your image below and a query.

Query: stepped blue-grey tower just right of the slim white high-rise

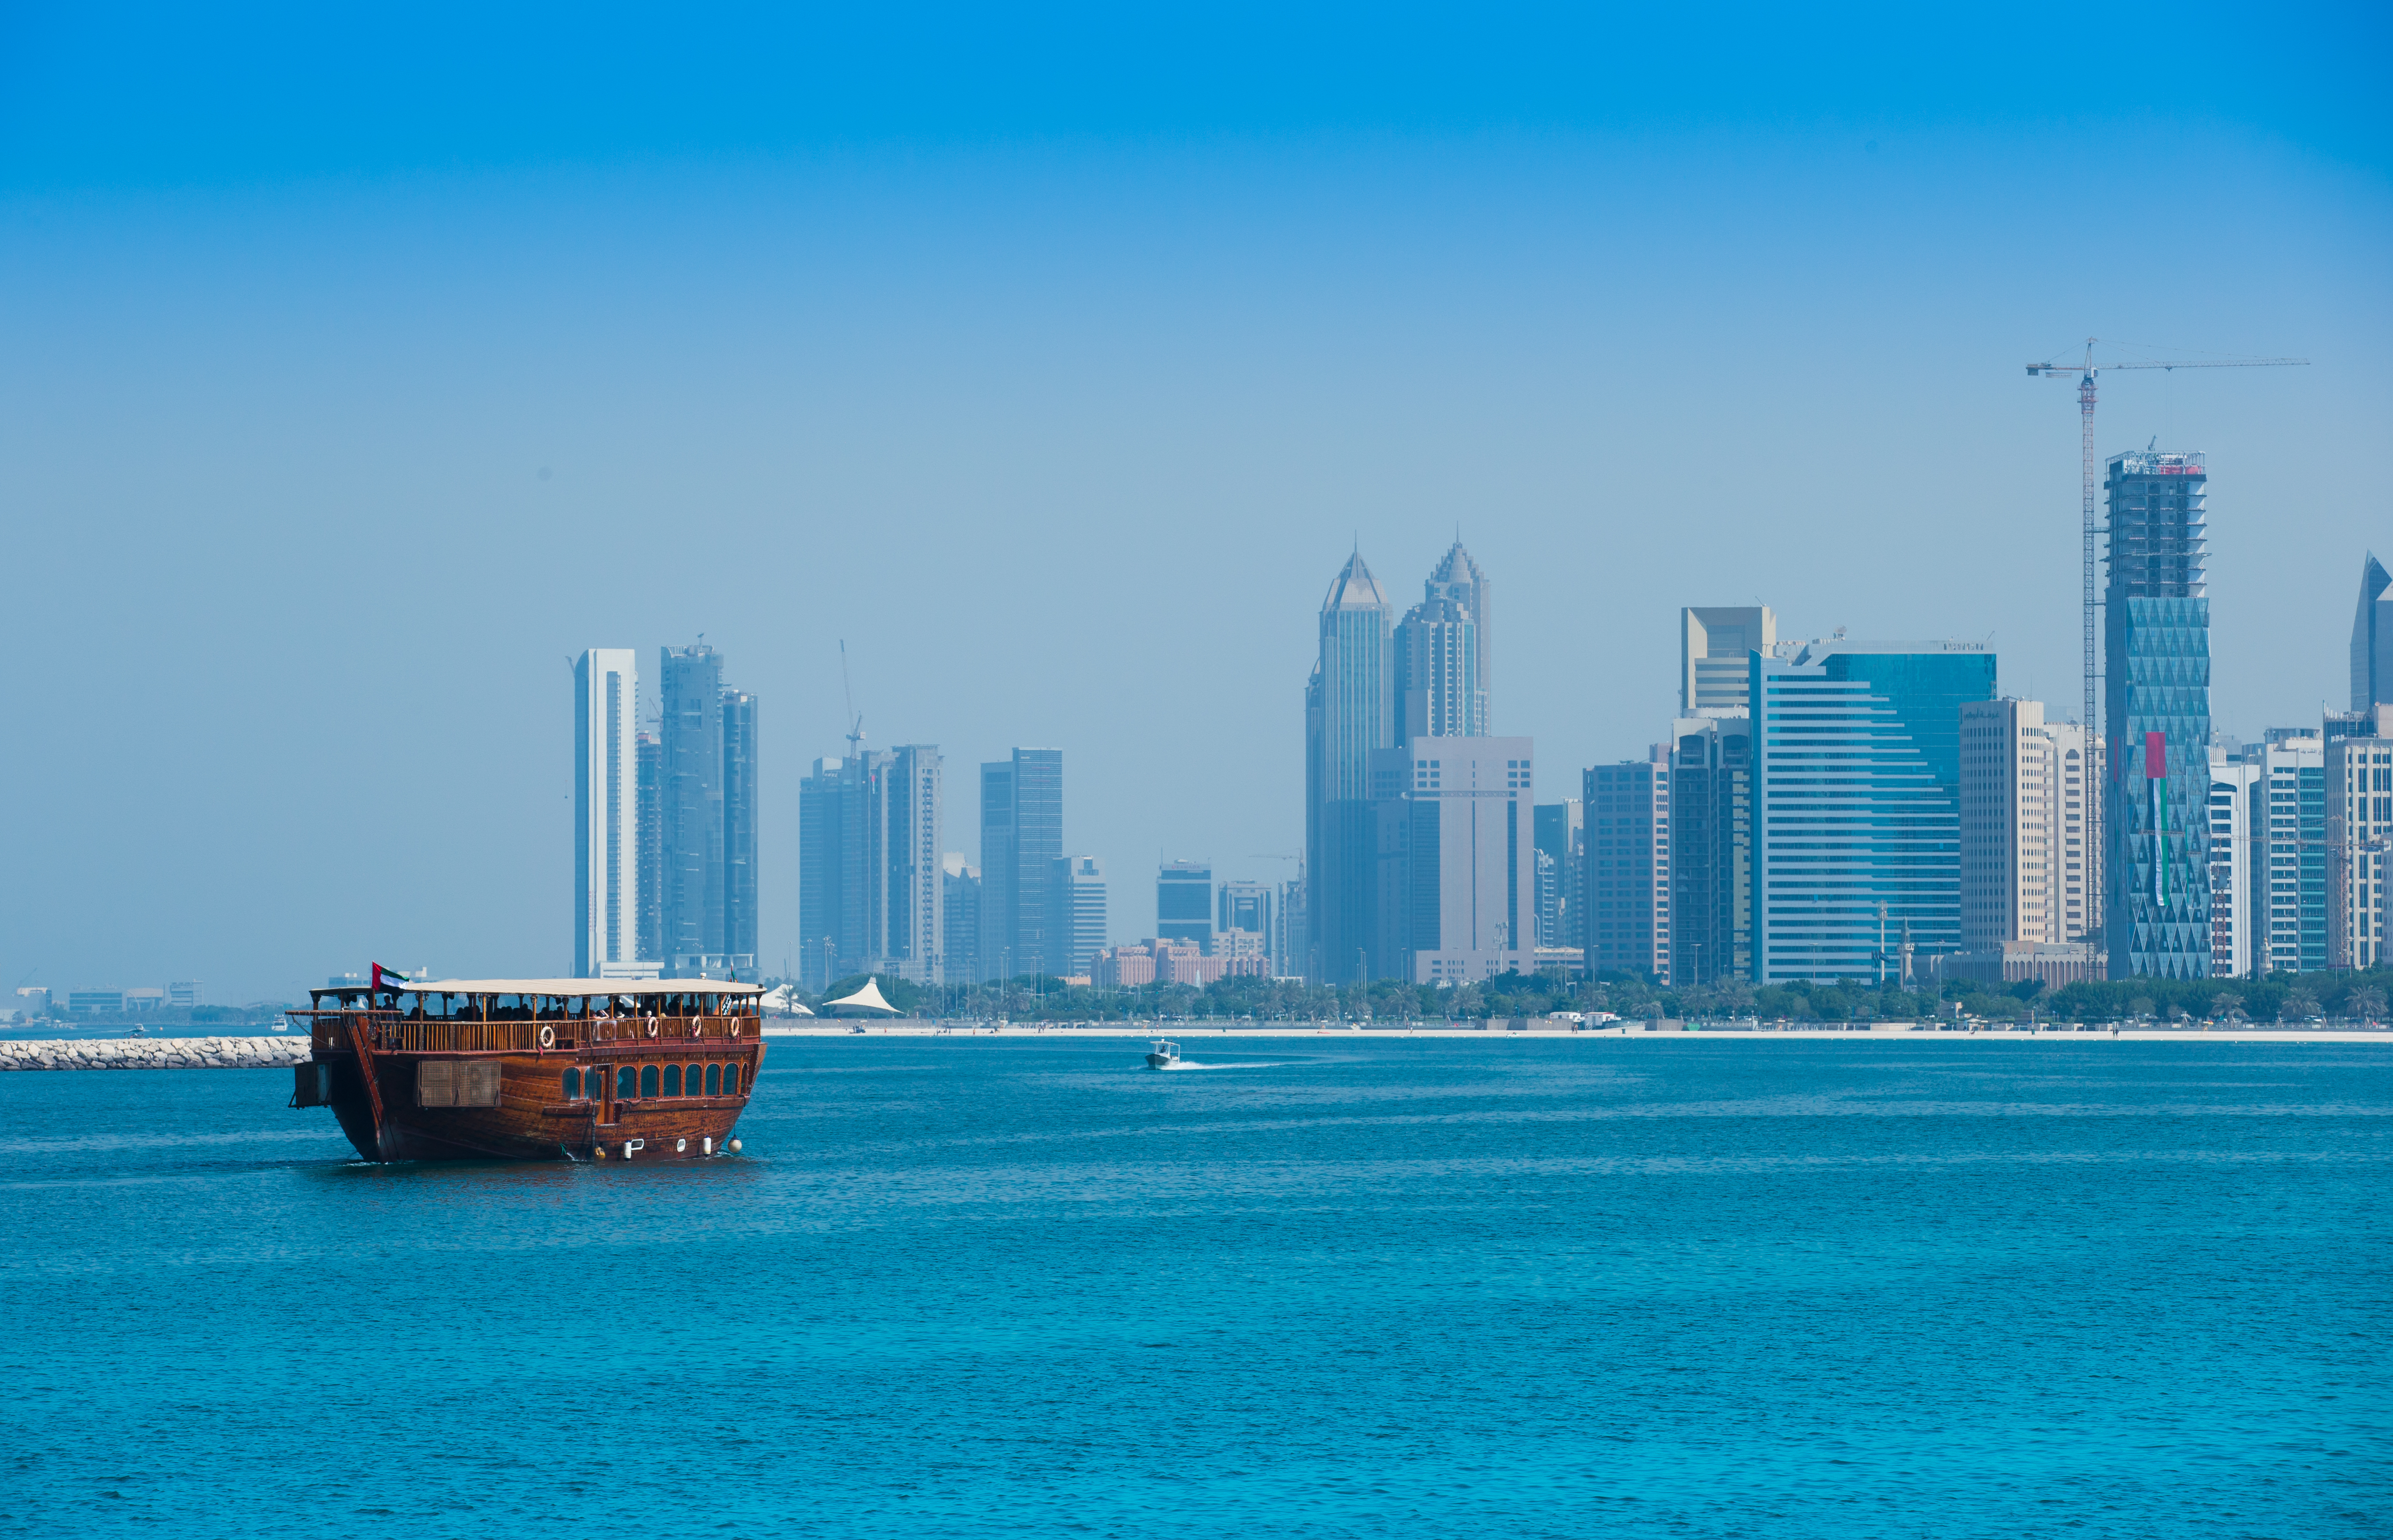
[656,646,759,978]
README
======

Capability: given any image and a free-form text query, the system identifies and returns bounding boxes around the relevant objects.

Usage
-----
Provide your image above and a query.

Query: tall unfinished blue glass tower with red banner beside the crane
[2104,452,2211,978]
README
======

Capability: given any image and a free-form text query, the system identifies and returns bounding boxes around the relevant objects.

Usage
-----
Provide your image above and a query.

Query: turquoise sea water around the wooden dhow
[0,1038,2393,1538]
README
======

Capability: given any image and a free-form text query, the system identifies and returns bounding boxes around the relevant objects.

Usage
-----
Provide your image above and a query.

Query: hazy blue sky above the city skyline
[0,5,2393,999]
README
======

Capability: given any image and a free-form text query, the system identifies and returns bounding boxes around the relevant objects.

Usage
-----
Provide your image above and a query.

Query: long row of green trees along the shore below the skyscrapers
[780,968,2393,1021]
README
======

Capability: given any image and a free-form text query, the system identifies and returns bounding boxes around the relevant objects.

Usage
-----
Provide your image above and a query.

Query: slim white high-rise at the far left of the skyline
[574,648,658,978]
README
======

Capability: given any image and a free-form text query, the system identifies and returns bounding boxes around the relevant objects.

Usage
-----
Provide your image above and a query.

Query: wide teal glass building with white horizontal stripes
[1751,638,1996,983]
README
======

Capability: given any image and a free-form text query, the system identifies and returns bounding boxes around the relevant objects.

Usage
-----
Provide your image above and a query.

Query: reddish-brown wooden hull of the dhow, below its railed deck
[294,1038,764,1165]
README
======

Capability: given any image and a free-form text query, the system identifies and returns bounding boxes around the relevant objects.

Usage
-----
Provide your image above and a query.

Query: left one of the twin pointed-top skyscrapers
[1304,552,1395,983]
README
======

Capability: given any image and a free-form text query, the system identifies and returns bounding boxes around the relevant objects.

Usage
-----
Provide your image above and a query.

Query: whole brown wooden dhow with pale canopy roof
[289,968,764,1160]
